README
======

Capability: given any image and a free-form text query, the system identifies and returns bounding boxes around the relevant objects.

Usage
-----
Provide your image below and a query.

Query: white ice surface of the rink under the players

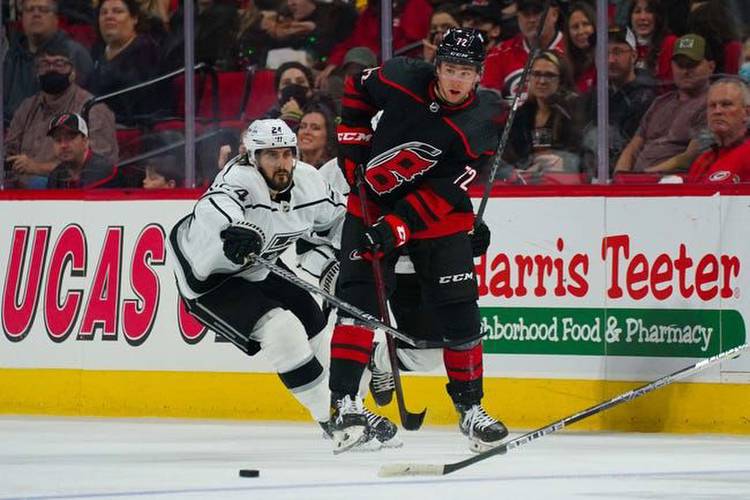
[0,417,750,500]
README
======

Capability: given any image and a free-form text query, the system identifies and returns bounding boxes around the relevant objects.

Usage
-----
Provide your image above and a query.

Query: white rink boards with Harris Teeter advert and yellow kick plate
[0,186,750,433]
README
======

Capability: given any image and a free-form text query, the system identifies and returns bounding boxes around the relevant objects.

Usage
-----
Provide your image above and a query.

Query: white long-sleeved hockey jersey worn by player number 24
[169,156,346,299]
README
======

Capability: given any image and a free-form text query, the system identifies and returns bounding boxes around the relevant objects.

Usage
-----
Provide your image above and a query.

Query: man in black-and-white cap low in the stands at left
[47,113,120,189]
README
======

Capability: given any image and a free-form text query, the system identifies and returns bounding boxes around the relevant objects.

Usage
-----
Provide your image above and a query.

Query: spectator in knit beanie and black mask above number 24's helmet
[265,61,314,129]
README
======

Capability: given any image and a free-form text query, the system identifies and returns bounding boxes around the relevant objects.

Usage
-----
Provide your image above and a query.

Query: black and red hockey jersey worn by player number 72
[338,58,502,238]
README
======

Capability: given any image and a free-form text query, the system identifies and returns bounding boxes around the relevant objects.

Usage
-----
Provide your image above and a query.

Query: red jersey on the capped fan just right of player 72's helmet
[482,32,565,99]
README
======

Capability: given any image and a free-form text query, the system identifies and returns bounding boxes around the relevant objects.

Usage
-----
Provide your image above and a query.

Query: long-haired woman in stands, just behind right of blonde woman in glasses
[565,2,596,93]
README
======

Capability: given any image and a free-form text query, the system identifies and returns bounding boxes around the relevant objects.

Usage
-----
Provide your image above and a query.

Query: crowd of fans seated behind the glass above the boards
[2,0,750,188]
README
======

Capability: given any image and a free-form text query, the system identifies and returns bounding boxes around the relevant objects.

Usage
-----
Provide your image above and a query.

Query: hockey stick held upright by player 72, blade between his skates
[357,165,427,431]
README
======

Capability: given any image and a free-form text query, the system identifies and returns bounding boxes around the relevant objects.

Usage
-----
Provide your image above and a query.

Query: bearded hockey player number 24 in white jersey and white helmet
[169,120,396,441]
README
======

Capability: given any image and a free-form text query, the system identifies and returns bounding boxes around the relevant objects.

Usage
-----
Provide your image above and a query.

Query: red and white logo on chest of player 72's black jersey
[365,141,442,194]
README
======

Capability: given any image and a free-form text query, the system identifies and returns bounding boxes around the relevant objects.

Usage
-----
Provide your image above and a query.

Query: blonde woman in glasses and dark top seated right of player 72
[504,50,581,173]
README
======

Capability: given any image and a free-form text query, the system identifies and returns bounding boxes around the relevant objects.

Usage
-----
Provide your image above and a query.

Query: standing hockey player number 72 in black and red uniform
[330,28,508,451]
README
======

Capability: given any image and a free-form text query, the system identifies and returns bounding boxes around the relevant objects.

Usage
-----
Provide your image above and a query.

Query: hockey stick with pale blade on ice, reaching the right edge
[378,344,748,477]
